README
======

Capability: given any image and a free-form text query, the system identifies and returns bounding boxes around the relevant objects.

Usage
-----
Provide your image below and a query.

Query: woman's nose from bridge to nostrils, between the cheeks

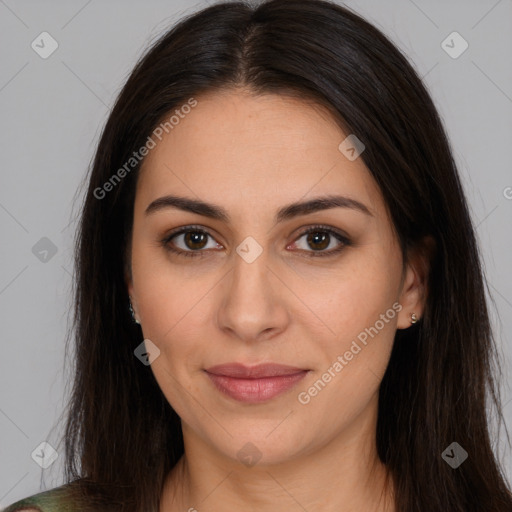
[217,244,292,343]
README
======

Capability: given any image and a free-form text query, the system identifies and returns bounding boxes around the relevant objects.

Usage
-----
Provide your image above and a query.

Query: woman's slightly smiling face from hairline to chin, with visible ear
[128,90,421,464]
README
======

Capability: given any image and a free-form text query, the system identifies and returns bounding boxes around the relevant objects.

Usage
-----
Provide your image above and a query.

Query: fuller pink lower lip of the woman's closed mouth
[206,370,308,404]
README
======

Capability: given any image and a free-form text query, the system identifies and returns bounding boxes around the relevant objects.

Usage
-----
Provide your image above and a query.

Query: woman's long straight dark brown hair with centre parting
[64,0,512,512]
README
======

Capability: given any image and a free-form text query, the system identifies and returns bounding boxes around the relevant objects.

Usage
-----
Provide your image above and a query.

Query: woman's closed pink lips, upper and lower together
[205,363,309,403]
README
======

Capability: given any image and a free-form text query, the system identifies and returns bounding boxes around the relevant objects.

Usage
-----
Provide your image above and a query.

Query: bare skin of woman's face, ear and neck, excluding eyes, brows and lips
[127,89,425,512]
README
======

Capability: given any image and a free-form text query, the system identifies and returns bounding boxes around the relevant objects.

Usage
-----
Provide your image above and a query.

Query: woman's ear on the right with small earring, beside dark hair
[397,236,436,329]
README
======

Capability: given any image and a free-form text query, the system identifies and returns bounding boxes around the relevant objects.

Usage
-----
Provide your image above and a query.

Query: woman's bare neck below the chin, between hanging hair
[160,394,394,512]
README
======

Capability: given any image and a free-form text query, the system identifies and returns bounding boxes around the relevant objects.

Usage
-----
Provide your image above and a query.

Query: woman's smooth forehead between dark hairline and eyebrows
[136,90,383,220]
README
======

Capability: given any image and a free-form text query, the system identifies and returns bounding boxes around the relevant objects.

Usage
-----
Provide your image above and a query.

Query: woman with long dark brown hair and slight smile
[7,0,512,512]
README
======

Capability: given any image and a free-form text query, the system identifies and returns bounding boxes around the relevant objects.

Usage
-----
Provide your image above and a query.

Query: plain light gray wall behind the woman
[0,0,512,508]
